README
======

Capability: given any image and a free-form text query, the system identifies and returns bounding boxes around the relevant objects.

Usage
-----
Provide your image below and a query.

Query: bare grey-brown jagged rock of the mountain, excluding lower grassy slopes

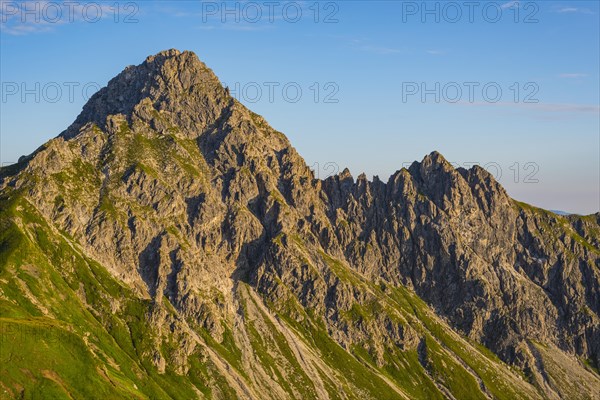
[0,50,600,398]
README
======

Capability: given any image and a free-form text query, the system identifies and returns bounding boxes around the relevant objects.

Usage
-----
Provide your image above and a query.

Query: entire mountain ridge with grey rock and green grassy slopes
[0,50,600,400]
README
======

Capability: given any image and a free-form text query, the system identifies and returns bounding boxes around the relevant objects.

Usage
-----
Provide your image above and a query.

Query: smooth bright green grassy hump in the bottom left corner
[0,318,145,399]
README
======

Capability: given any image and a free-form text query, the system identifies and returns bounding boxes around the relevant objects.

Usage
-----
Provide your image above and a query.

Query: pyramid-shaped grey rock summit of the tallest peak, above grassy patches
[63,49,232,138]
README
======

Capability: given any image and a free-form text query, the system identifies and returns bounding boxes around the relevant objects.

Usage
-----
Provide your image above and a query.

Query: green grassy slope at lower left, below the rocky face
[0,194,226,399]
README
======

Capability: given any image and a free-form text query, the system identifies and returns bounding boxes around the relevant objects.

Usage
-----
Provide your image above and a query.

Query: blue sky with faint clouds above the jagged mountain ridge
[0,0,600,214]
